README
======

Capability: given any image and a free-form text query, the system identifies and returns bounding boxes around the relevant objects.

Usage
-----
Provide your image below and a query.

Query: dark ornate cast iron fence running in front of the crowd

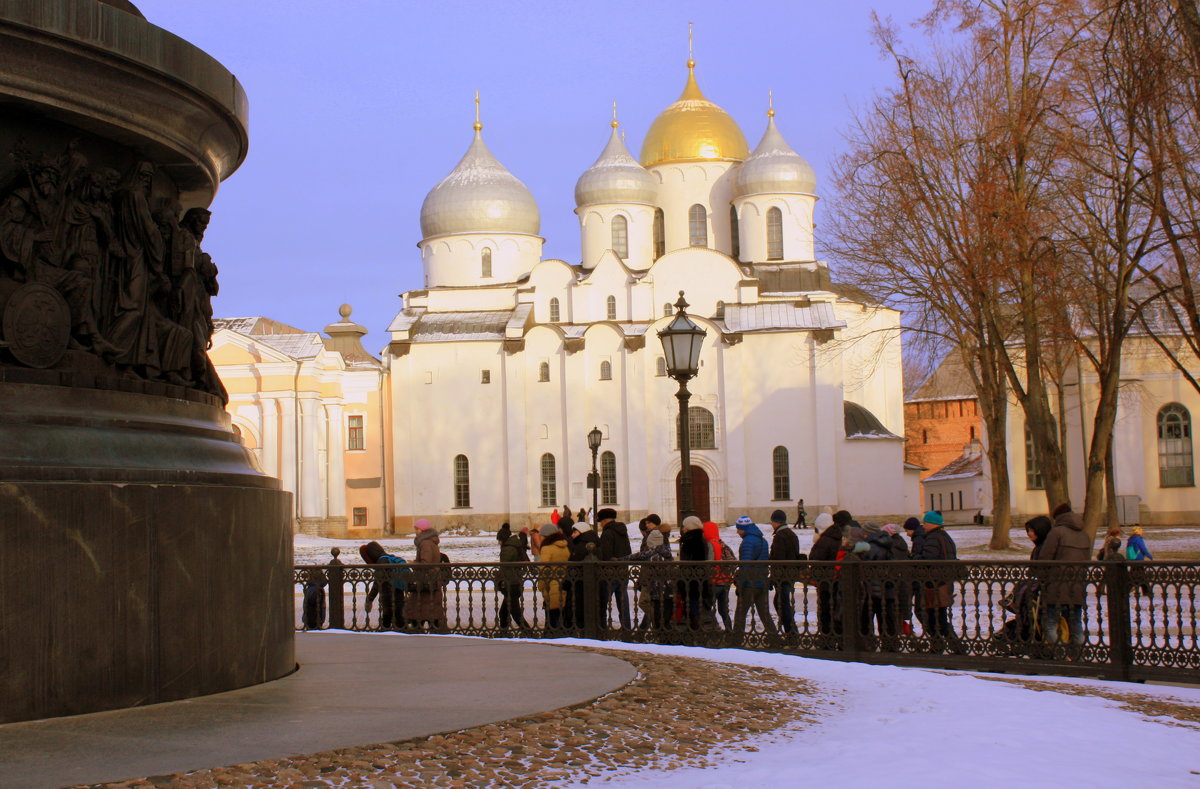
[295,559,1200,681]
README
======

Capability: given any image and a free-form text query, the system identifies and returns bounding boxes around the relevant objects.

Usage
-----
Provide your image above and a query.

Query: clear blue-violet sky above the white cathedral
[134,0,931,351]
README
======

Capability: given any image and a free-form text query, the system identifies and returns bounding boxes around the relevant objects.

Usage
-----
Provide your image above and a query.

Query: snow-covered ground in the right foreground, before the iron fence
[539,639,1200,789]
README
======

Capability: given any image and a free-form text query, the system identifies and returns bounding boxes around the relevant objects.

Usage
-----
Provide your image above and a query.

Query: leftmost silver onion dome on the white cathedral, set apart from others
[421,128,541,239]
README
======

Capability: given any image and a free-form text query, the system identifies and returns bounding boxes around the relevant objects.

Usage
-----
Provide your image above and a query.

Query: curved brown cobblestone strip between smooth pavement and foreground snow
[88,648,829,789]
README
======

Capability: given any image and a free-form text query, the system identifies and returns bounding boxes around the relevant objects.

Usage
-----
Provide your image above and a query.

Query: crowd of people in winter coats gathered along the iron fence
[304,501,1153,652]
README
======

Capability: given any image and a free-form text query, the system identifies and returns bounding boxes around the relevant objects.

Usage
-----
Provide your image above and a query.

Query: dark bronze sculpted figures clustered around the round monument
[0,143,226,399]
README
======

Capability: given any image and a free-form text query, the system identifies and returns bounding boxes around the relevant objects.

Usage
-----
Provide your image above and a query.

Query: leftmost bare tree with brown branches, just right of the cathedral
[828,24,1010,549]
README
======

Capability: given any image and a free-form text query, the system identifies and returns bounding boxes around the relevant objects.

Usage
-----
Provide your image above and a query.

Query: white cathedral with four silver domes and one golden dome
[384,61,917,531]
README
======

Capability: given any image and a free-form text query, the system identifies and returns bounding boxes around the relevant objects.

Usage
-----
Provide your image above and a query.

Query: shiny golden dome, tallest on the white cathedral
[642,60,750,167]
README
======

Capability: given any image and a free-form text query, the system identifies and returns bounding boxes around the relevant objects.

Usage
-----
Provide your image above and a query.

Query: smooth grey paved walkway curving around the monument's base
[0,633,636,789]
